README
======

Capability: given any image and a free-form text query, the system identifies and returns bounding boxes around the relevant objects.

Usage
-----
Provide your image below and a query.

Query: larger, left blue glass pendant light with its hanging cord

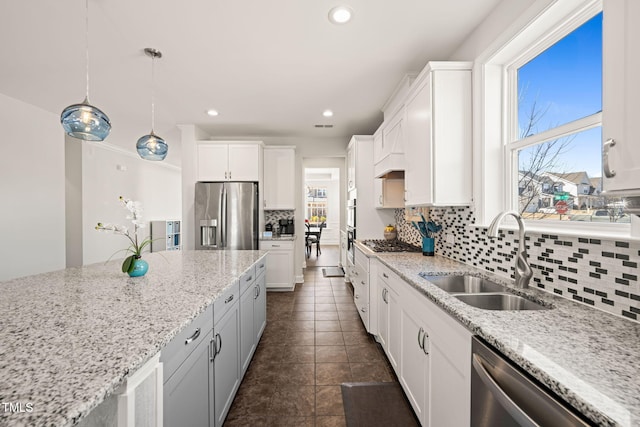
[60,0,111,141]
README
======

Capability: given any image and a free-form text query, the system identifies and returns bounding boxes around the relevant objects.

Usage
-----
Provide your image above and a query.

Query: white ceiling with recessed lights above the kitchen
[0,0,499,146]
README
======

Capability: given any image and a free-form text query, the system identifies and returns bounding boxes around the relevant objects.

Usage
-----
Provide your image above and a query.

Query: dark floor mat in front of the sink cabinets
[341,382,420,427]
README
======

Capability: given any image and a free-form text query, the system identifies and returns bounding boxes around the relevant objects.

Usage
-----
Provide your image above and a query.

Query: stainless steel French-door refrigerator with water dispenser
[195,182,258,249]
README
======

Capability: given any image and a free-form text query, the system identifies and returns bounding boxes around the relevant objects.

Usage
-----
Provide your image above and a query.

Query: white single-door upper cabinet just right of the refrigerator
[264,146,296,210]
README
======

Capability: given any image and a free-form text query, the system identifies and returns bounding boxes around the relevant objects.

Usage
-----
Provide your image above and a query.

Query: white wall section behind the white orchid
[82,142,182,264]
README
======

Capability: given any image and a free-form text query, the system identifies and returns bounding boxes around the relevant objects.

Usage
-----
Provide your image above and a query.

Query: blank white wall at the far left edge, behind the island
[0,94,65,280]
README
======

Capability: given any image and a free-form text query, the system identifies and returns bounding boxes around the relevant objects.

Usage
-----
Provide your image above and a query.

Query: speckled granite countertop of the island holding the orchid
[0,251,267,426]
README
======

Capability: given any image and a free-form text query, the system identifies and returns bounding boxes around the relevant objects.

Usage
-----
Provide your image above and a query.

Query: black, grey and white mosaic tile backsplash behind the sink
[395,207,640,321]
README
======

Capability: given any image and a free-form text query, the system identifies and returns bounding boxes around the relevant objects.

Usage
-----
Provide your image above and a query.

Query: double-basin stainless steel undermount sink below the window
[420,274,549,311]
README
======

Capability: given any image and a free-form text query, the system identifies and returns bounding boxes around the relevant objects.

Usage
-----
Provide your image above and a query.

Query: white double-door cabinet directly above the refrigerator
[197,141,262,181]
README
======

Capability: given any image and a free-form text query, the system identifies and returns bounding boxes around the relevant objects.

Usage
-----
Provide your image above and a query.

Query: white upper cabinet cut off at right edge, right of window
[602,0,640,195]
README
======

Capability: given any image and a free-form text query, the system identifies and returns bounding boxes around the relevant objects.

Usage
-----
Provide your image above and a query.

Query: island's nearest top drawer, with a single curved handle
[160,306,213,382]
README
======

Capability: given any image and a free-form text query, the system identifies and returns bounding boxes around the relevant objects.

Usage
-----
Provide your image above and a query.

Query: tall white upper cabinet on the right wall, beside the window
[403,62,472,206]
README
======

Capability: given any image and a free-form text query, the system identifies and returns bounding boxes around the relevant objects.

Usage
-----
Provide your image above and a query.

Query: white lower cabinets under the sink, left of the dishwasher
[372,261,472,427]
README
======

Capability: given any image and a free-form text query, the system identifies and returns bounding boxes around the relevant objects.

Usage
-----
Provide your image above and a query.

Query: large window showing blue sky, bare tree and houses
[507,13,629,223]
